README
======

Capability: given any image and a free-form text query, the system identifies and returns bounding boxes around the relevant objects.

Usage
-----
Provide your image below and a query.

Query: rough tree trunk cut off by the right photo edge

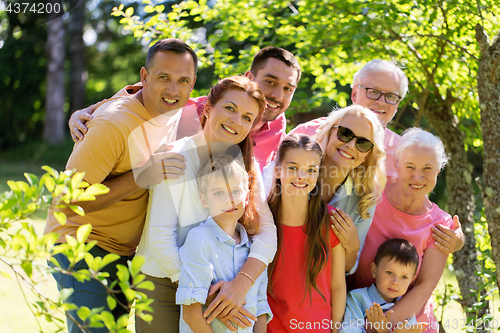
[476,24,500,287]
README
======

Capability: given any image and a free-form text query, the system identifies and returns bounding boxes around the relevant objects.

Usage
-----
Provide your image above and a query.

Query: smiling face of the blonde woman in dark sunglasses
[325,112,373,172]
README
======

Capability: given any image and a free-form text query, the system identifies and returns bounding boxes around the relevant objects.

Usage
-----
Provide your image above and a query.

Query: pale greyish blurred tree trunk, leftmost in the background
[43,6,66,144]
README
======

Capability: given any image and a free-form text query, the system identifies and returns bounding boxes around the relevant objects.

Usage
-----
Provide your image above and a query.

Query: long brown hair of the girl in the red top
[268,134,330,301]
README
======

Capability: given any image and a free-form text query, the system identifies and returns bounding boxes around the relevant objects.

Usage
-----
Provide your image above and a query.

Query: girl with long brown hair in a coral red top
[267,134,346,333]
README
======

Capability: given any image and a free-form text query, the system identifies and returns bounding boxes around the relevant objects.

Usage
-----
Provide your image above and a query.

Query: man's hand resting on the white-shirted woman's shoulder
[134,145,186,188]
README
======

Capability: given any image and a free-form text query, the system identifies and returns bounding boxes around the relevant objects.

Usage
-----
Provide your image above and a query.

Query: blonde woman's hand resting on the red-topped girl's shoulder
[330,208,360,272]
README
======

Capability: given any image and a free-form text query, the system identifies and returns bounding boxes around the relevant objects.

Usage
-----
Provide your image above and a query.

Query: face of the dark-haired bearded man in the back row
[245,58,299,122]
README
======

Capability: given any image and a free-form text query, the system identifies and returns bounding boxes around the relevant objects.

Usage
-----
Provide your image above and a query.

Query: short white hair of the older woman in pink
[394,127,449,170]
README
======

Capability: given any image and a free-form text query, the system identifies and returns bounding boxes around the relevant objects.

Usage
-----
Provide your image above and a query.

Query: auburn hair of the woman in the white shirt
[200,76,266,235]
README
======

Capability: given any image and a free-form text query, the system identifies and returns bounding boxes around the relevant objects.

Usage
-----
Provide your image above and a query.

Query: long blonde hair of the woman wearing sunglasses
[315,105,387,218]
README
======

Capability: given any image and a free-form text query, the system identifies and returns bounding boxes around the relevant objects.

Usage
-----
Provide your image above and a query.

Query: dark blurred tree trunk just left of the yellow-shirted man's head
[68,0,87,115]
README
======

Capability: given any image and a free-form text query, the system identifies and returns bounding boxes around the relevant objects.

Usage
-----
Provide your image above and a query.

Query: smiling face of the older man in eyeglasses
[351,71,401,126]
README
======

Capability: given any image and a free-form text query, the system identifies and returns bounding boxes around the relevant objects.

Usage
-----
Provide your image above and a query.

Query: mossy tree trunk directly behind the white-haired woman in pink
[419,90,486,317]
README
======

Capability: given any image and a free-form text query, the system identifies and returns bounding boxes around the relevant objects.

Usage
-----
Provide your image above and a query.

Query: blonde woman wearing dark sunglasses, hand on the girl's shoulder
[292,105,386,274]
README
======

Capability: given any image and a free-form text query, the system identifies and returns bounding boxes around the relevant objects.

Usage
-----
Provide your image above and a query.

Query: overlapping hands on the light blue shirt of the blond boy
[203,278,257,331]
